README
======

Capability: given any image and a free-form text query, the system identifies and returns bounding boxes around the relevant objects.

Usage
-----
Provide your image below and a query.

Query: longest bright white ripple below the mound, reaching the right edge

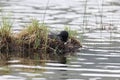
[10,65,120,73]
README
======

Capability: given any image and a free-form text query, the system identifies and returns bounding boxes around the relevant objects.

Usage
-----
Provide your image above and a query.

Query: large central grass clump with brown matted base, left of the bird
[15,19,49,58]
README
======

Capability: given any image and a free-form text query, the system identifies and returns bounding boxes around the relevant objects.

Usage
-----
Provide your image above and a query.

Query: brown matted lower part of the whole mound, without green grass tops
[0,32,82,56]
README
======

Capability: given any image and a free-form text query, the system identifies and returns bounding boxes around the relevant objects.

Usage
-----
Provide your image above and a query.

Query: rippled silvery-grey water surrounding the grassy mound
[0,0,120,80]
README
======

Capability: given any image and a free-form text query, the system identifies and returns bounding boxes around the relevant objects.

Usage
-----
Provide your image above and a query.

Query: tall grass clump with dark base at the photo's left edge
[0,17,12,52]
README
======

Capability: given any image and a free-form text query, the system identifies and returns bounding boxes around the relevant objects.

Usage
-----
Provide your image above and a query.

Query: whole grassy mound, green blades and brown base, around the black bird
[0,19,81,58]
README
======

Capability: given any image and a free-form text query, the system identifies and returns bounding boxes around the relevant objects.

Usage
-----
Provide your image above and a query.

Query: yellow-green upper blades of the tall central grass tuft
[25,19,48,49]
